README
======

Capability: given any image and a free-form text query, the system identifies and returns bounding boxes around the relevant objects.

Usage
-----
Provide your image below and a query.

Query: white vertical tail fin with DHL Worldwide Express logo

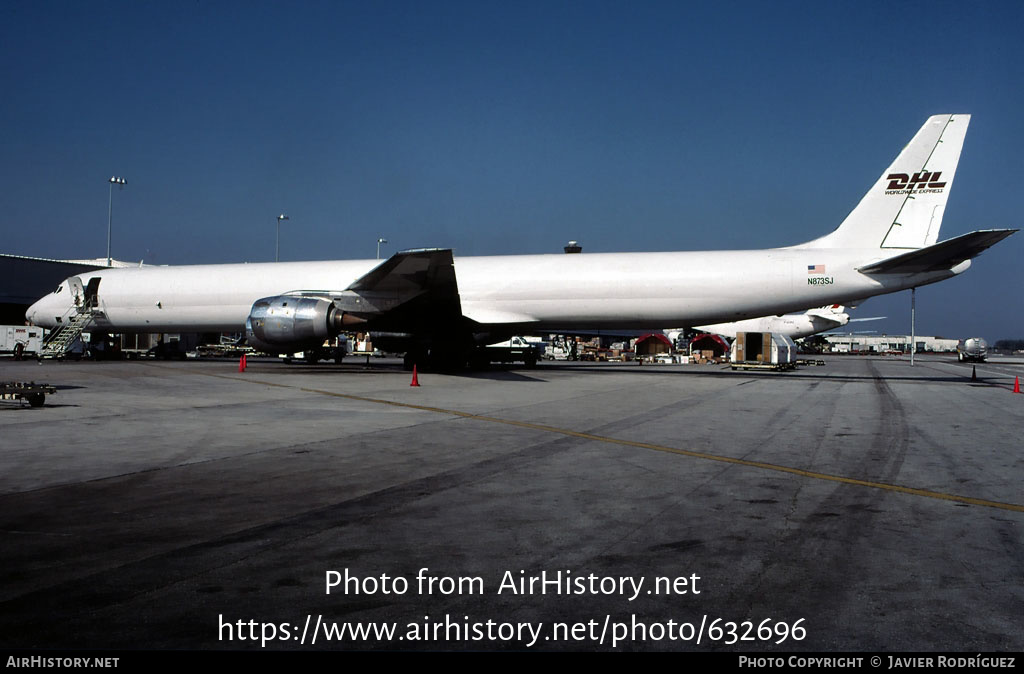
[798,115,971,250]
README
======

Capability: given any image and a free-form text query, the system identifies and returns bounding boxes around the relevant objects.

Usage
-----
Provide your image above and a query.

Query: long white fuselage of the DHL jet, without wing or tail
[28,249,967,332]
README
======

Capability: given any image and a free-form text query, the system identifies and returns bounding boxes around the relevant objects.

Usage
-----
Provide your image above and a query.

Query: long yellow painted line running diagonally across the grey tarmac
[192,364,1024,512]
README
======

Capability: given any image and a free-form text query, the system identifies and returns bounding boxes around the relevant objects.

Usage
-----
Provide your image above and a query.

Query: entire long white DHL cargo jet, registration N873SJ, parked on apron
[27,115,1017,367]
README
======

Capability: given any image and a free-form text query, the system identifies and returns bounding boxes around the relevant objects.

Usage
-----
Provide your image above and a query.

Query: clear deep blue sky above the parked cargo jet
[0,1,1024,340]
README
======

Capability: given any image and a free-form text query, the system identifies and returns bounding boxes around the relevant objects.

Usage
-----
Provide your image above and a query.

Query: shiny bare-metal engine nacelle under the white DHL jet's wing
[246,295,344,351]
